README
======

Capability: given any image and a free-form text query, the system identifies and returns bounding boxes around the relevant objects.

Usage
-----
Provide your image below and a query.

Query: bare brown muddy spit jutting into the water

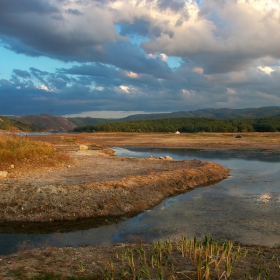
[0,151,228,222]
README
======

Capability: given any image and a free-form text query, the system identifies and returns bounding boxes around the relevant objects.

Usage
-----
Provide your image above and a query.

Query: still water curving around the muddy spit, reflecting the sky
[0,148,280,254]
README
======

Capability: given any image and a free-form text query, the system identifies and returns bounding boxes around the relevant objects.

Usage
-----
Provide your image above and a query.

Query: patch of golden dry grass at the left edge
[0,135,70,170]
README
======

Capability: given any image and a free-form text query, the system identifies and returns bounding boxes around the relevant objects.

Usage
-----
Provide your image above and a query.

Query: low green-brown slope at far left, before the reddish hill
[0,116,43,131]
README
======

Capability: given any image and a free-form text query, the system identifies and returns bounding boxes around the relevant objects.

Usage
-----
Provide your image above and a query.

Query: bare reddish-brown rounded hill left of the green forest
[22,114,76,131]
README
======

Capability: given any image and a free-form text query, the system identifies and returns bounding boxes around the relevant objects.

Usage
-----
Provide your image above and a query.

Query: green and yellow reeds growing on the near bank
[105,236,248,280]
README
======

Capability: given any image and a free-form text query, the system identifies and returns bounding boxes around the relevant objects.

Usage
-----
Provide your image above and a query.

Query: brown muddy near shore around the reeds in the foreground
[0,243,280,280]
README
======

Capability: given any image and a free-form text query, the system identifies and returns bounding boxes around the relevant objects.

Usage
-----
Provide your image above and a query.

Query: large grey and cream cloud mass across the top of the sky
[0,0,280,73]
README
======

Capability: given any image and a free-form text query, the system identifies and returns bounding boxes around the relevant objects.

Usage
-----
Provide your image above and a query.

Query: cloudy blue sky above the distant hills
[0,0,280,118]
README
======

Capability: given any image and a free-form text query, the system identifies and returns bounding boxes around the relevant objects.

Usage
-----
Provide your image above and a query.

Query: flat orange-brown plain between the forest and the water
[33,132,280,152]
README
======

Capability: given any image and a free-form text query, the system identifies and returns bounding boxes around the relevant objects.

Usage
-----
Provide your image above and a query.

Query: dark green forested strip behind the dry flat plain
[74,116,280,132]
